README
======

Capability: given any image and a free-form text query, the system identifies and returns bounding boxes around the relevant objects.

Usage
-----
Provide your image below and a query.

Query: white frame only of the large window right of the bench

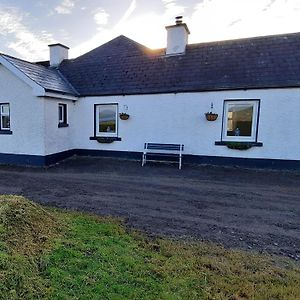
[222,99,260,142]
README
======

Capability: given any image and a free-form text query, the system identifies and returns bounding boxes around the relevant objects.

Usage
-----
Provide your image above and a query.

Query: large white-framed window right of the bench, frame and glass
[222,100,259,142]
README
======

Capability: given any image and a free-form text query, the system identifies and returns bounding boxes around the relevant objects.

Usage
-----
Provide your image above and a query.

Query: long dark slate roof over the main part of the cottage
[59,33,300,96]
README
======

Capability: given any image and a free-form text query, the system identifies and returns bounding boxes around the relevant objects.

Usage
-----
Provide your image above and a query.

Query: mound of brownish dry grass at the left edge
[0,196,61,255]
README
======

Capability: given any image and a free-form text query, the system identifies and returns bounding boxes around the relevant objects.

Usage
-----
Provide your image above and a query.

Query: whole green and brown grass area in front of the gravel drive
[0,196,300,300]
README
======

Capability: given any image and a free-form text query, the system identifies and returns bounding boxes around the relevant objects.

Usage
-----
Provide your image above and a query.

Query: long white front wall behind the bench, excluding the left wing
[69,89,300,160]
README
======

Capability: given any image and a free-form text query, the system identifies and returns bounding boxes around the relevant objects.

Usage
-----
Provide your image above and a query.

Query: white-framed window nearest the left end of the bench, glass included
[95,104,118,137]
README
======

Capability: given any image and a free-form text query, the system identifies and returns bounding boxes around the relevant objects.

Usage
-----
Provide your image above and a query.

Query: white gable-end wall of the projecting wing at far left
[0,65,45,155]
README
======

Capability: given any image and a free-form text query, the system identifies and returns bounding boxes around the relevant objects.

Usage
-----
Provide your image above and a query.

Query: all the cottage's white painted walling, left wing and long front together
[0,61,300,160]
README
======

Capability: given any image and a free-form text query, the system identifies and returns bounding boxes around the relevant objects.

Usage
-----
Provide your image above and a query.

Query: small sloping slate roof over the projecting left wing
[0,54,77,96]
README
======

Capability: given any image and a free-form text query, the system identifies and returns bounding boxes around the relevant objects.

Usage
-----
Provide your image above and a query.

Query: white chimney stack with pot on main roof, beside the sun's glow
[166,16,190,55]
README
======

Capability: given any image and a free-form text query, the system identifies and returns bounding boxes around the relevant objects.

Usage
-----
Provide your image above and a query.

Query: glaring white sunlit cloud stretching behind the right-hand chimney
[71,0,300,56]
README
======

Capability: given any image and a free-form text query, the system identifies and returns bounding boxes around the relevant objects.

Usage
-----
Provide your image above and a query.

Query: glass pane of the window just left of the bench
[99,105,116,133]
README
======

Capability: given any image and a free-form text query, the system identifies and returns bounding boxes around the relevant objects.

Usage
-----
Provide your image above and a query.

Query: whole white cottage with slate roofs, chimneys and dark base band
[0,19,300,168]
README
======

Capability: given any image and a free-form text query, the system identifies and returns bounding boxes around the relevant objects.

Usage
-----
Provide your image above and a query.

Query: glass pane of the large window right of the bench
[227,104,254,136]
